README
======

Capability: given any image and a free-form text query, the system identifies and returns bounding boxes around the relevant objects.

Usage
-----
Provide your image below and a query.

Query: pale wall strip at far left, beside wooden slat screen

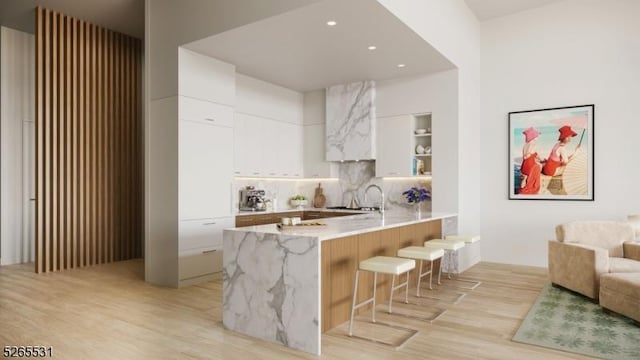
[0,27,35,265]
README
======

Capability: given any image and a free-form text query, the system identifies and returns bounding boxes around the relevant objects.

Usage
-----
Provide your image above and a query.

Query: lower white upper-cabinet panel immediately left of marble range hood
[303,124,338,178]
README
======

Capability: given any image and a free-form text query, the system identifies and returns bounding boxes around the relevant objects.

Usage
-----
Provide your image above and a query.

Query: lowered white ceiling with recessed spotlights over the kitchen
[184,0,455,92]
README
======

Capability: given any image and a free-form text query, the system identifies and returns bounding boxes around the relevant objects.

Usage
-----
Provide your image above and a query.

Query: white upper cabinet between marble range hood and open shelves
[376,115,413,177]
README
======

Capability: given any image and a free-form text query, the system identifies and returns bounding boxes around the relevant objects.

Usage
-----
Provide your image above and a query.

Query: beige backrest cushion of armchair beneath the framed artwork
[556,221,635,257]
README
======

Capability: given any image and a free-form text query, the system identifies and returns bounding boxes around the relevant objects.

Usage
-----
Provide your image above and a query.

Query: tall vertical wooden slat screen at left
[35,8,142,272]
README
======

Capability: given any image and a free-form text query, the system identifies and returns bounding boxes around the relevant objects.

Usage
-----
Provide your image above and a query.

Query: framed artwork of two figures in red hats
[509,104,594,201]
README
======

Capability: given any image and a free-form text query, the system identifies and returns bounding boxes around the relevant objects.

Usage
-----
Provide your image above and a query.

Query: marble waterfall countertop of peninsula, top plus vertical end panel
[222,211,456,355]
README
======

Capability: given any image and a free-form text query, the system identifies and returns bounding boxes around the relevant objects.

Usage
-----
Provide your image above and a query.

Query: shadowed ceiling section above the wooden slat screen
[0,0,144,39]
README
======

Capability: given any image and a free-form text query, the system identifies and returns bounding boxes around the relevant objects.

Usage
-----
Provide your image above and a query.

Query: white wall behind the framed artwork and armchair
[478,0,640,266]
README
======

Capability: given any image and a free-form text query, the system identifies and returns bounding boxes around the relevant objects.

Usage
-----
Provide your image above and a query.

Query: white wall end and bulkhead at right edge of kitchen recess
[378,0,484,233]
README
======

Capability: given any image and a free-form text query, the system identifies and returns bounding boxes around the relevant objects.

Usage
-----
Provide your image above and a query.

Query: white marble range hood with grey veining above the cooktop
[325,81,376,161]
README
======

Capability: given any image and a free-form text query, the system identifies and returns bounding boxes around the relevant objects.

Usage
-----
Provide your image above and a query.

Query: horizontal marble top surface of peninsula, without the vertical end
[227,209,456,241]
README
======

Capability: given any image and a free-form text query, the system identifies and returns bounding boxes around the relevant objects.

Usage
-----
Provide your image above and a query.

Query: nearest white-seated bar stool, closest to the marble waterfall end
[349,256,418,348]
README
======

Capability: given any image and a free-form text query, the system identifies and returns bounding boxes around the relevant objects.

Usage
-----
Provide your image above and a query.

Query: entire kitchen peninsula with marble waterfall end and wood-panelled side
[222,212,457,354]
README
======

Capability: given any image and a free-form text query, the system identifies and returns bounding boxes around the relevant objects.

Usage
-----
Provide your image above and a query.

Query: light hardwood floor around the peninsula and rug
[0,260,585,360]
